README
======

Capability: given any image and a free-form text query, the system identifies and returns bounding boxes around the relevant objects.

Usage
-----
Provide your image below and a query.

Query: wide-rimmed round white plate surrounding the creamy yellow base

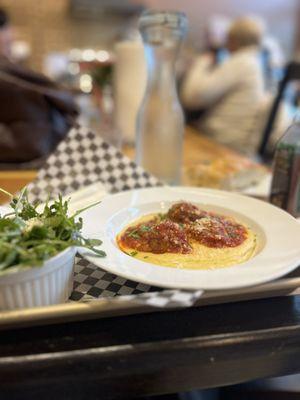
[82,187,300,290]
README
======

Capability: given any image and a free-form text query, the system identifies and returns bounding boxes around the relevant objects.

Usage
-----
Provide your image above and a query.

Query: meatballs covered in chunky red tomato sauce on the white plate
[120,202,247,254]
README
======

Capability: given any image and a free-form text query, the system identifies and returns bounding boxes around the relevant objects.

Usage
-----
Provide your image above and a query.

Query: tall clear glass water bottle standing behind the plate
[136,11,187,184]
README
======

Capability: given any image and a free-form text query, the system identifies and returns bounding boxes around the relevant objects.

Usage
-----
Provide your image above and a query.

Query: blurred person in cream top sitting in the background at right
[180,17,288,155]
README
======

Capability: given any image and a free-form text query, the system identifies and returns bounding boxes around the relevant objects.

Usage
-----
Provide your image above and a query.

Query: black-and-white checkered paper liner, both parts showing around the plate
[28,126,202,307]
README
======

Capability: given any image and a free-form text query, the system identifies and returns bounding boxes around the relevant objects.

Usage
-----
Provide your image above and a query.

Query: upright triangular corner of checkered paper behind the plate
[28,126,160,201]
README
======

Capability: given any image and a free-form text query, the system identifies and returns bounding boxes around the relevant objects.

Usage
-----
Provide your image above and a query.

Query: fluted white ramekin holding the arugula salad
[0,247,76,310]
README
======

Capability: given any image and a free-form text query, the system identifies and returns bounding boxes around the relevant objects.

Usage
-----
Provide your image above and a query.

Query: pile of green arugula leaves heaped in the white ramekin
[0,188,106,273]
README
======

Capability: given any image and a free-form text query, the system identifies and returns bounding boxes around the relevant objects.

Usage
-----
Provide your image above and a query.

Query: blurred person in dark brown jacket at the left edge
[0,9,77,169]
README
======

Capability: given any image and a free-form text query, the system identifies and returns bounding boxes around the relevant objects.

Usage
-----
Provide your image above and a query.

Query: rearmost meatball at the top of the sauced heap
[167,202,208,224]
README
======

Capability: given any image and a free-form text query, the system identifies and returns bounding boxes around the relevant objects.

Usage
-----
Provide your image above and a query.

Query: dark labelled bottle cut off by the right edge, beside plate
[270,118,300,218]
